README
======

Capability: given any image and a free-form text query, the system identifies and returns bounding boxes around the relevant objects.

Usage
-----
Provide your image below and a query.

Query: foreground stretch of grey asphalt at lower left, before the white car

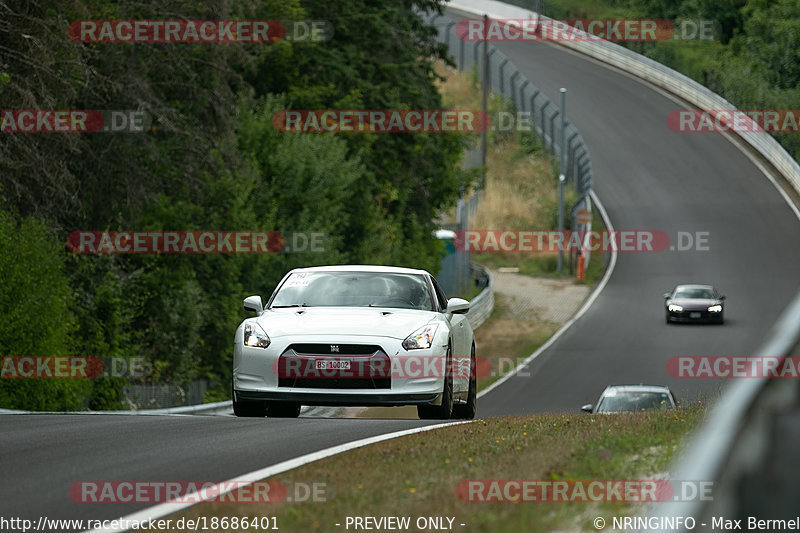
[0,415,436,531]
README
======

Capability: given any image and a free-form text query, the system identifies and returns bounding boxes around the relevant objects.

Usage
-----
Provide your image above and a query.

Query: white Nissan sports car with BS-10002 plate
[233,266,476,419]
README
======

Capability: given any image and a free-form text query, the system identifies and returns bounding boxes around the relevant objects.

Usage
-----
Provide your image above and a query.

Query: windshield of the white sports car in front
[270,272,433,311]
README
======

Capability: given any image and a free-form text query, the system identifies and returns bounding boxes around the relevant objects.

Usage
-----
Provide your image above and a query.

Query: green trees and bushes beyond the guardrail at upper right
[512,0,800,159]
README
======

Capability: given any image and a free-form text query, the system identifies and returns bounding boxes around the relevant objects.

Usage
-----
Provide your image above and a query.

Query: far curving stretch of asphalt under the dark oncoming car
[462,17,800,417]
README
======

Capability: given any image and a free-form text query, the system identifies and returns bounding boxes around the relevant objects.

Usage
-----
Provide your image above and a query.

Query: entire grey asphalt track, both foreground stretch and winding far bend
[0,7,800,519]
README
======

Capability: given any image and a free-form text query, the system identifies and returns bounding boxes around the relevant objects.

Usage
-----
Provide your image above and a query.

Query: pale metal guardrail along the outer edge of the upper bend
[448,0,800,197]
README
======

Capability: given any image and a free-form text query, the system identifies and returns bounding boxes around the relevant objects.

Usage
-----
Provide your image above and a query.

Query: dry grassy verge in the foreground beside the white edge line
[156,405,705,533]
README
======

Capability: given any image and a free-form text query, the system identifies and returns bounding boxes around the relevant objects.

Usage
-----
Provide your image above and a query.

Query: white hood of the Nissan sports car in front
[256,307,436,339]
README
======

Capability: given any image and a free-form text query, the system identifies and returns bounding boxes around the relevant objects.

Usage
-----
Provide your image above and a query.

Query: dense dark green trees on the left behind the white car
[0,0,474,409]
